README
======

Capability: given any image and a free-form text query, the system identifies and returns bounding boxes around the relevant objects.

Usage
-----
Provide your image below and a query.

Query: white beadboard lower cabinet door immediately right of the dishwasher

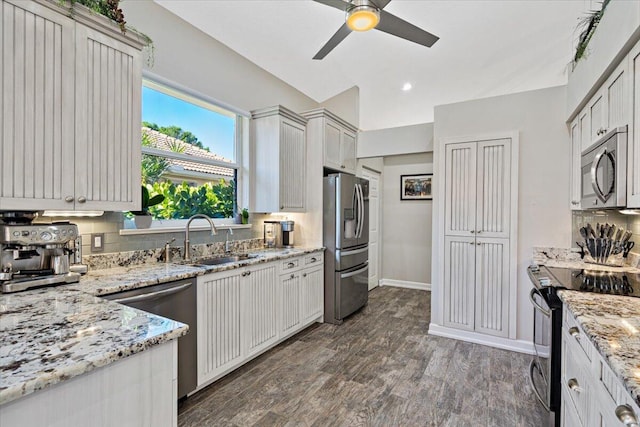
[197,270,243,385]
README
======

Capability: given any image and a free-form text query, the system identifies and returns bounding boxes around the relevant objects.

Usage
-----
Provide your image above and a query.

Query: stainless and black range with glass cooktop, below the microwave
[527,266,640,425]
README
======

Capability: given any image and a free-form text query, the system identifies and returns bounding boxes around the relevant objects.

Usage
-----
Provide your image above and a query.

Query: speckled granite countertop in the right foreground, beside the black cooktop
[558,291,640,405]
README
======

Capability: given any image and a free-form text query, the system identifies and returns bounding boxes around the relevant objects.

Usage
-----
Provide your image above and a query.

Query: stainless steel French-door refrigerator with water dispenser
[323,173,369,324]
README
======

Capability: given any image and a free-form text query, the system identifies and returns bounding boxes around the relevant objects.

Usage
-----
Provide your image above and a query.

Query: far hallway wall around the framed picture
[382,153,433,284]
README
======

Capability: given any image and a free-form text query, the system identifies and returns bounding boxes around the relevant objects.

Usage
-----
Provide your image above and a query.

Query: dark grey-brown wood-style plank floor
[178,287,547,427]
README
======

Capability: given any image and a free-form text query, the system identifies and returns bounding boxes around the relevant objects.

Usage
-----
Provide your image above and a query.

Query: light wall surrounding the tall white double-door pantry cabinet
[431,86,571,341]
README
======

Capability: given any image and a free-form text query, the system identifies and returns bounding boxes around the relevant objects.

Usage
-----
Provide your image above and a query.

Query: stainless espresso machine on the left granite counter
[0,213,86,293]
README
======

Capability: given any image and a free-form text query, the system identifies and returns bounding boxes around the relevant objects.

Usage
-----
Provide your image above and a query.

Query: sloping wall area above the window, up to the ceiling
[121,0,318,111]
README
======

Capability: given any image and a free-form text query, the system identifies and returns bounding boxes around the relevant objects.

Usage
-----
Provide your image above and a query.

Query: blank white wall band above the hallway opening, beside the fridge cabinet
[358,123,433,158]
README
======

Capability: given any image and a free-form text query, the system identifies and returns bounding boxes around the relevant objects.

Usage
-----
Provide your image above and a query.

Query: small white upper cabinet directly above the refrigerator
[301,108,358,175]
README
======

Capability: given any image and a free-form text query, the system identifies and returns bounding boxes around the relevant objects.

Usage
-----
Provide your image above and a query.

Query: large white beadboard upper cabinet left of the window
[0,0,142,210]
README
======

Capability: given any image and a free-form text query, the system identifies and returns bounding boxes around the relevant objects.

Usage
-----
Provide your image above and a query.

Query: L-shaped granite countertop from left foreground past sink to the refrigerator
[0,248,323,404]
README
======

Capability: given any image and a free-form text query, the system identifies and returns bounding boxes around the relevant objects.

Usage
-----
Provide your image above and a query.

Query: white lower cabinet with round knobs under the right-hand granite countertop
[561,307,640,427]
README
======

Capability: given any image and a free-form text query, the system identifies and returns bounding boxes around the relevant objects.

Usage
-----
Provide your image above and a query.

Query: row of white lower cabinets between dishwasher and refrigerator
[198,252,324,389]
